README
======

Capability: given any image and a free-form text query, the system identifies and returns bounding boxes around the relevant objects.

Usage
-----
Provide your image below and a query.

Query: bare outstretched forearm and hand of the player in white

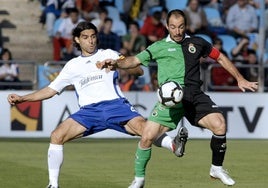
[7,87,57,105]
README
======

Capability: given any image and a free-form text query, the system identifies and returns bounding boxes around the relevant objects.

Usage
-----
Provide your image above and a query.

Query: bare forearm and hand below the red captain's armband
[217,53,258,92]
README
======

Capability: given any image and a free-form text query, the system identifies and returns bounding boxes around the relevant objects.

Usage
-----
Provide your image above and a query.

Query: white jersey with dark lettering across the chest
[48,49,124,106]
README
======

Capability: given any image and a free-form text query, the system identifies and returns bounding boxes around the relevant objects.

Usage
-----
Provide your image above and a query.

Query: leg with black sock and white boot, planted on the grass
[198,113,235,185]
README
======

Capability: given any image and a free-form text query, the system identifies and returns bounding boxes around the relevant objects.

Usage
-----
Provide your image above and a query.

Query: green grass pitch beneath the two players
[0,138,268,188]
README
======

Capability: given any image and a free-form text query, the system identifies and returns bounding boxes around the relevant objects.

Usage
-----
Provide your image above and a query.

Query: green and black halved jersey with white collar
[137,35,212,88]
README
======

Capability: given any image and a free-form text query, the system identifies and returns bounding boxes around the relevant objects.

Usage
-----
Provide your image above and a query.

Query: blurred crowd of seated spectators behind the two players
[0,0,268,91]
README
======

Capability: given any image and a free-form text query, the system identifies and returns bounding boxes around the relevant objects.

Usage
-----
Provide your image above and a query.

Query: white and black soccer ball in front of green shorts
[157,81,183,107]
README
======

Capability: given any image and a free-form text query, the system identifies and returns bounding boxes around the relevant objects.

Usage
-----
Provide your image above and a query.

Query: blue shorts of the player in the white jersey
[70,98,141,136]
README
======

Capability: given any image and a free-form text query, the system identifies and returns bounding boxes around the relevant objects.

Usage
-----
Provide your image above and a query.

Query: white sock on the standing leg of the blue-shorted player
[47,144,63,187]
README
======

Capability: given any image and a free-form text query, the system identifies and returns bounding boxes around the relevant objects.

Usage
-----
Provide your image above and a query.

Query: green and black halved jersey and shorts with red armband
[137,36,221,129]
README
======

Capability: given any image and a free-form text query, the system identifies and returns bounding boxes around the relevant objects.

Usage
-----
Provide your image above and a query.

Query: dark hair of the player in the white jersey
[72,21,98,50]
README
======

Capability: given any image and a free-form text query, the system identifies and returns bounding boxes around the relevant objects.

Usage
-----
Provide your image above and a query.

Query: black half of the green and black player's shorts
[182,90,222,126]
